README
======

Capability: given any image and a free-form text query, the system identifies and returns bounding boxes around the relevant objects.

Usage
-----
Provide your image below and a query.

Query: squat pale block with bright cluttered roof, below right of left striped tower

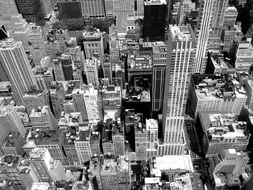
[29,106,58,131]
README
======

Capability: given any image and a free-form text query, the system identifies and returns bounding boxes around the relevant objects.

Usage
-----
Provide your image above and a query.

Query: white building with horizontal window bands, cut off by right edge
[235,38,253,72]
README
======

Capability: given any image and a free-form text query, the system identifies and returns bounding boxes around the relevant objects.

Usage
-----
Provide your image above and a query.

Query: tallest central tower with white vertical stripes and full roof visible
[159,25,195,155]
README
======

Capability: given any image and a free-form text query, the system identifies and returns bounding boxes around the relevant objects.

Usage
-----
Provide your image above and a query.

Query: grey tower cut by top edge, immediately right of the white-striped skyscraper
[208,0,228,50]
